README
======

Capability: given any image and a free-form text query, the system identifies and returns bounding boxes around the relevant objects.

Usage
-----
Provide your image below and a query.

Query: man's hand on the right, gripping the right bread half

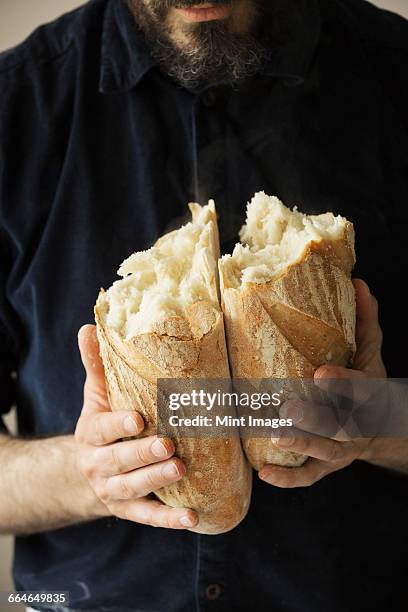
[259,279,408,488]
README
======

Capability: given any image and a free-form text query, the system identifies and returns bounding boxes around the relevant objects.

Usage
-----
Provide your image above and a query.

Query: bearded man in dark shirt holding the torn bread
[0,0,408,612]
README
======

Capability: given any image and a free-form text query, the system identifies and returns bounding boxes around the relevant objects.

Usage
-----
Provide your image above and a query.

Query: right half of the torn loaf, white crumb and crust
[219,192,355,470]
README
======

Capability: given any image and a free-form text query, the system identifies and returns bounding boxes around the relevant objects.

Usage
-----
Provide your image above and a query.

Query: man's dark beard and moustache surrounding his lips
[126,0,271,89]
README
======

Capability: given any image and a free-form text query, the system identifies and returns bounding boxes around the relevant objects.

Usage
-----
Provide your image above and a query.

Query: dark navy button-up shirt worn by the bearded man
[0,0,408,612]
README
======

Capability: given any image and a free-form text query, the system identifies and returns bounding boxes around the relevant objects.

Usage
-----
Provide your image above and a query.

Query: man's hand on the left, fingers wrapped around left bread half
[75,325,198,529]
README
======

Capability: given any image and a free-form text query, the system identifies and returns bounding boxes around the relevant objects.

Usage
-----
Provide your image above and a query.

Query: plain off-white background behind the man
[0,0,408,612]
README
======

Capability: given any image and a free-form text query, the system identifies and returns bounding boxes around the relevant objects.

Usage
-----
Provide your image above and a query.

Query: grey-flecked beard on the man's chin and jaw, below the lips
[127,0,271,89]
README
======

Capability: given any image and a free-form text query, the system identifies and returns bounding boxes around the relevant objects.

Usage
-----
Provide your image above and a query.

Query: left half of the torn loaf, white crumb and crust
[95,201,251,534]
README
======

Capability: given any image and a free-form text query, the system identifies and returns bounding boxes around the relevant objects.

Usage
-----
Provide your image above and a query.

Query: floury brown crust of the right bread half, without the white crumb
[219,234,356,470]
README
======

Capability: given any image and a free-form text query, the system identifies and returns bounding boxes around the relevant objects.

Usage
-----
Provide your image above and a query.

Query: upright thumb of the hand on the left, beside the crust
[78,325,110,410]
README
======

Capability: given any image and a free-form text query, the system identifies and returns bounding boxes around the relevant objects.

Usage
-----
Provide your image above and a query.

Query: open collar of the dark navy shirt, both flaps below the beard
[99,0,321,93]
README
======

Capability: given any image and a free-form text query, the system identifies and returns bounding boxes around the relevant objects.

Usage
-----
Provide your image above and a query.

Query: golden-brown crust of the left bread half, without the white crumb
[95,300,251,534]
